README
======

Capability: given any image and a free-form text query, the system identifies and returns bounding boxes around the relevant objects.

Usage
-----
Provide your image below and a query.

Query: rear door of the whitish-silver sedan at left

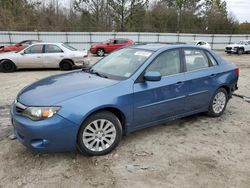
[43,44,64,68]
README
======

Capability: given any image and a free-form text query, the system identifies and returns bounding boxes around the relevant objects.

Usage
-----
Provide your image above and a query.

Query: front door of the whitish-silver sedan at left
[18,44,44,68]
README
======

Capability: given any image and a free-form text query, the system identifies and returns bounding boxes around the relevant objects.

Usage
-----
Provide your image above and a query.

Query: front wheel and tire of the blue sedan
[77,111,122,156]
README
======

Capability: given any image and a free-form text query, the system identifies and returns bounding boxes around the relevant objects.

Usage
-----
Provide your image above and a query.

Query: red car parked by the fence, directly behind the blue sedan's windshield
[90,39,134,56]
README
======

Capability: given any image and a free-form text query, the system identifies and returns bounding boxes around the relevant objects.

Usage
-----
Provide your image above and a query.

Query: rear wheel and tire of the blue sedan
[207,88,228,117]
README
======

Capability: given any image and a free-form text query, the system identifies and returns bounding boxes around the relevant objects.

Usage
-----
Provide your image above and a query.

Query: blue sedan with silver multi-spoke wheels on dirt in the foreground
[11,44,239,155]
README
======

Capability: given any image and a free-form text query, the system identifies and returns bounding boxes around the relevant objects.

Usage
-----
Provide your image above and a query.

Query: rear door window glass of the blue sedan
[184,49,209,71]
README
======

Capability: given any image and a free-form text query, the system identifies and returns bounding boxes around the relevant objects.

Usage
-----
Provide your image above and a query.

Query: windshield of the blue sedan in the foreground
[91,48,152,80]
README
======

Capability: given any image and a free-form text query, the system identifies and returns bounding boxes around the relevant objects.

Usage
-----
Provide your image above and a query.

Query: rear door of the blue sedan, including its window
[183,48,217,113]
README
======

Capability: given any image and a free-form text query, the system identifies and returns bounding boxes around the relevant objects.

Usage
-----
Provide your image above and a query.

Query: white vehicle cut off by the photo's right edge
[225,40,250,55]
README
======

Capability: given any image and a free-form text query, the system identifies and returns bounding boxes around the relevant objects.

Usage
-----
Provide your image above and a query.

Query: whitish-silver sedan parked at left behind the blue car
[0,43,88,72]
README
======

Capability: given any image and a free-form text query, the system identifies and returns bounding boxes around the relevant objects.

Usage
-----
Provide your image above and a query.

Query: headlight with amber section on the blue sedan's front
[22,107,60,121]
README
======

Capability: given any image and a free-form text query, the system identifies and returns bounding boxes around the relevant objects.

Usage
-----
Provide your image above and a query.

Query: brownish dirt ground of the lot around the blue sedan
[0,52,250,188]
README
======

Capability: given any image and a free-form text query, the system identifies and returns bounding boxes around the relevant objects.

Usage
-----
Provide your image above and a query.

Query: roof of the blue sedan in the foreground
[130,43,200,52]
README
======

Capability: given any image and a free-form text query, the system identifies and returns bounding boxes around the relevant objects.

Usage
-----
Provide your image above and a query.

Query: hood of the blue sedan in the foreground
[17,71,118,106]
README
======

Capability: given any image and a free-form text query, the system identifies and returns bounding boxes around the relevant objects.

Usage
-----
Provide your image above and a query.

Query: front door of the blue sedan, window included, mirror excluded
[134,50,187,127]
